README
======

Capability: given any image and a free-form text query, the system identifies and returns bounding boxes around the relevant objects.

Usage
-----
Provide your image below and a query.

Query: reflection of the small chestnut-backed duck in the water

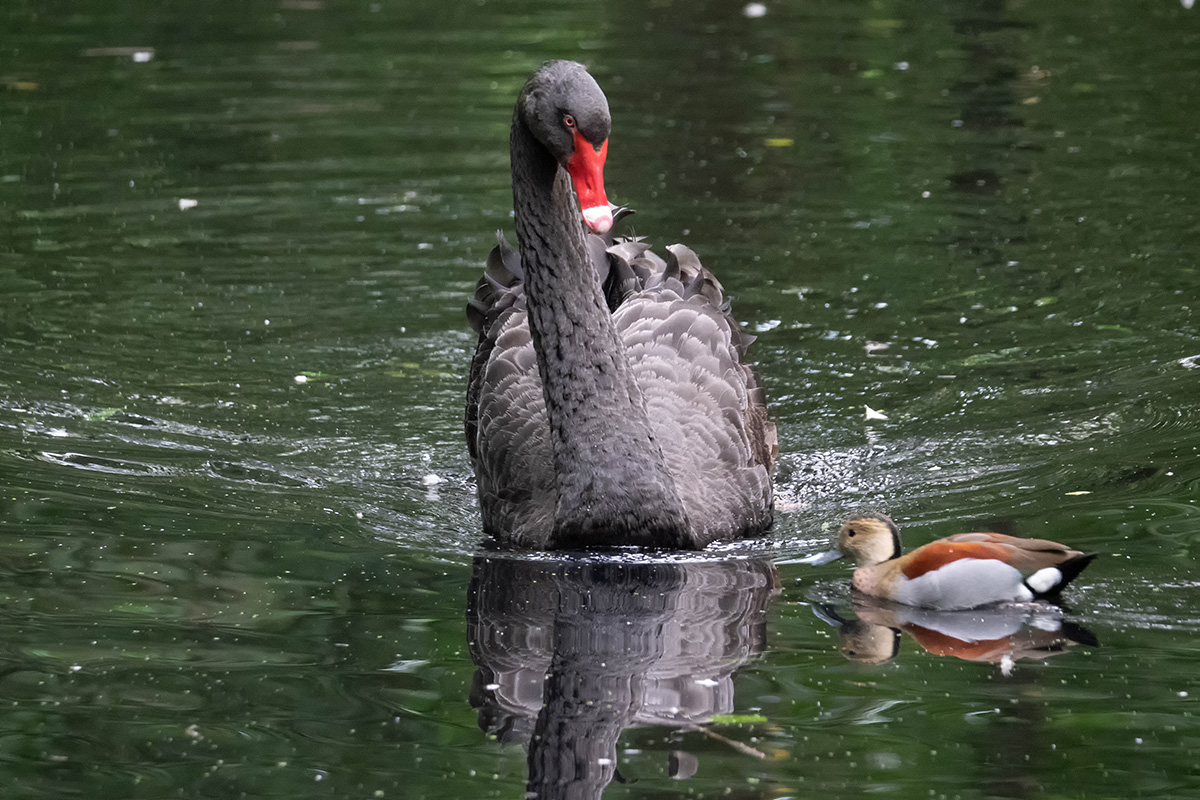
[812,593,1099,675]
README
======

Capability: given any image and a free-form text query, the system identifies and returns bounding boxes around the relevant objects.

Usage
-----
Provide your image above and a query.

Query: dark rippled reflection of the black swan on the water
[467,555,779,798]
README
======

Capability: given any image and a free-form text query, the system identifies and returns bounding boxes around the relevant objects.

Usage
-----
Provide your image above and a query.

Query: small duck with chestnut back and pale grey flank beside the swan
[810,512,1097,610]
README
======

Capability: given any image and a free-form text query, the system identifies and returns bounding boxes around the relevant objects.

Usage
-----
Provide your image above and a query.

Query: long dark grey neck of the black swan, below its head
[511,113,697,548]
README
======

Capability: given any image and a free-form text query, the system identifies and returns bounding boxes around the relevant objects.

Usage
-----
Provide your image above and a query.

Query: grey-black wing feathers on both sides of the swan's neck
[466,214,778,545]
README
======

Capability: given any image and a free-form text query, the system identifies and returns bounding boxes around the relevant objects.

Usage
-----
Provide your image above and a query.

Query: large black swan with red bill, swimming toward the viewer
[466,61,778,549]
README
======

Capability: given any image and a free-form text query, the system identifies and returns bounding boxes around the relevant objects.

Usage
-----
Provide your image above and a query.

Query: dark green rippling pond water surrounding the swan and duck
[0,0,1200,798]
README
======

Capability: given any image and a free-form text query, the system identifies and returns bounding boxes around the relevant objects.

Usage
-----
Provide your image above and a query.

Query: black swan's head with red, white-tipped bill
[517,61,612,234]
